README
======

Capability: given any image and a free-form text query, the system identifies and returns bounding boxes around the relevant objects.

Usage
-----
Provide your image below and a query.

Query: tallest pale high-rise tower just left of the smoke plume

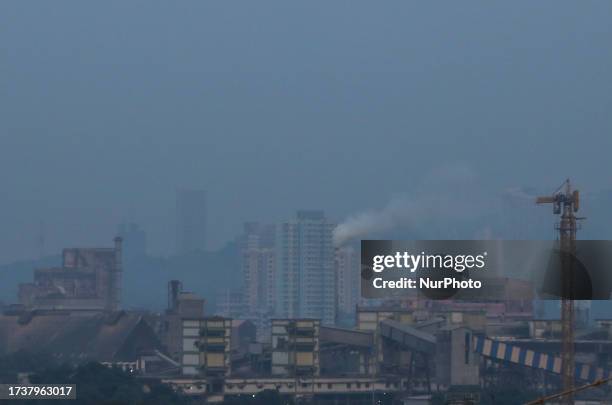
[276,211,337,325]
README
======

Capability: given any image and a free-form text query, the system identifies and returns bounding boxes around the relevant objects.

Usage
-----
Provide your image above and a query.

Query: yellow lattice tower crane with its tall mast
[536,179,580,405]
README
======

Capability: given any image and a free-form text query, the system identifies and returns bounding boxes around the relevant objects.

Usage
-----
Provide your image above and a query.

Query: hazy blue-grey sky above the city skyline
[0,0,612,262]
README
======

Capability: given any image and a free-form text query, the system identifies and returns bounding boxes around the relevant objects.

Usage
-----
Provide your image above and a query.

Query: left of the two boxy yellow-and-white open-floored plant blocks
[181,317,232,377]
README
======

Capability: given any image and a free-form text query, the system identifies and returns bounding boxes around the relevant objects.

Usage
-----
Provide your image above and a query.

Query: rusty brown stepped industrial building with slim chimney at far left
[18,237,123,311]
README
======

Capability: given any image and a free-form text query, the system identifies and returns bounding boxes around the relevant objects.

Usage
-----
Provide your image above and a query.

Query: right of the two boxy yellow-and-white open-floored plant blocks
[272,319,320,376]
